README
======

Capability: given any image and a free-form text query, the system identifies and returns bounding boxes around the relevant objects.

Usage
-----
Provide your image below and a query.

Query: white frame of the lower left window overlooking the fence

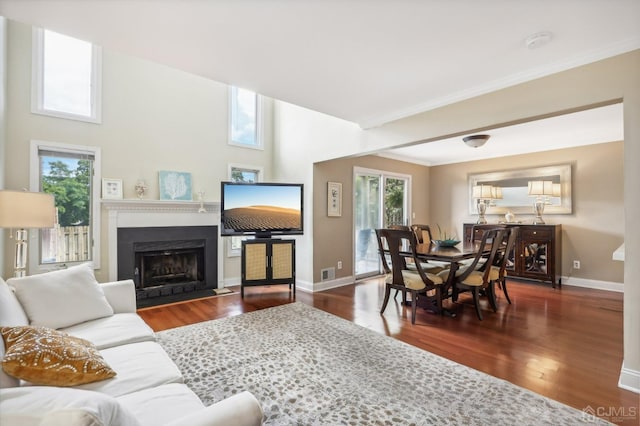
[28,140,102,273]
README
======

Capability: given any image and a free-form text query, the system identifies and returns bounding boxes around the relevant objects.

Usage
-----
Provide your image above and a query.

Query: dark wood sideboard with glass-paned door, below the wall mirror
[464,223,562,288]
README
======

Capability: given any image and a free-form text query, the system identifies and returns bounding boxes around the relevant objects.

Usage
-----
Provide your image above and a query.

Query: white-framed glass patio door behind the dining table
[353,167,411,278]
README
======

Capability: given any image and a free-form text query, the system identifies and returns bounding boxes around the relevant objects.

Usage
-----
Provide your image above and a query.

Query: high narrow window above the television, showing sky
[229,87,262,149]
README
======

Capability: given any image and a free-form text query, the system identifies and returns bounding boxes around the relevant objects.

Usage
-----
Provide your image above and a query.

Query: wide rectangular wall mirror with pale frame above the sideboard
[468,164,572,215]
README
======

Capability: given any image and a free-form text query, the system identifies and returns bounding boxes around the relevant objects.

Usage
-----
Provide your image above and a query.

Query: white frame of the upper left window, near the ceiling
[31,27,102,124]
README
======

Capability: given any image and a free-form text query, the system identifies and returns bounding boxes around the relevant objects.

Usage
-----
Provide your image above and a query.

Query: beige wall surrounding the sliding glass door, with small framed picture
[313,155,429,282]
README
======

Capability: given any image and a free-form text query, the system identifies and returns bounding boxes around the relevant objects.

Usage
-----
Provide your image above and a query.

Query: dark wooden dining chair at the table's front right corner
[452,228,506,320]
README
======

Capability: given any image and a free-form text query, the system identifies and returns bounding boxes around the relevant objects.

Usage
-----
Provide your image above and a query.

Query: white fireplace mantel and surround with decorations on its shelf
[102,199,224,286]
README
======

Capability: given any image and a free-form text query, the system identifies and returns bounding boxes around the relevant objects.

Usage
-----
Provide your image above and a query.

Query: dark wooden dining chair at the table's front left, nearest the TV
[376,229,443,324]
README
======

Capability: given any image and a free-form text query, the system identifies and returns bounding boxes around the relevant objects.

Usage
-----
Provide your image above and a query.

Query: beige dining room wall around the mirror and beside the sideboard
[430,142,624,283]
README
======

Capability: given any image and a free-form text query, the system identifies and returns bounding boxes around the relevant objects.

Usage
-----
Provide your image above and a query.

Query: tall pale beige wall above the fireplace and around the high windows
[4,21,273,281]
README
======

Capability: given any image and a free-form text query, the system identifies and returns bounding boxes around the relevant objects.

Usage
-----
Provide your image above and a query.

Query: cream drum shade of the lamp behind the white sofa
[0,190,56,229]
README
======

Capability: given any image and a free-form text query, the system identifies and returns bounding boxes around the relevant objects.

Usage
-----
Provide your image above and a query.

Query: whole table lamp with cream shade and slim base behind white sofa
[0,190,56,277]
